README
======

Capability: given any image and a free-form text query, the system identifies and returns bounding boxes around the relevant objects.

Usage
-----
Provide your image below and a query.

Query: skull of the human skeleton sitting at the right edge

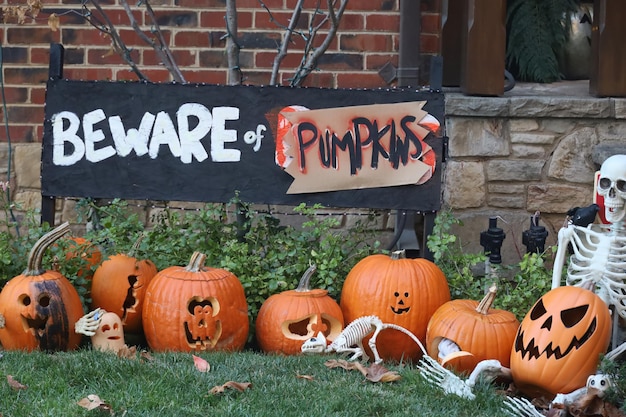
[598,155,626,223]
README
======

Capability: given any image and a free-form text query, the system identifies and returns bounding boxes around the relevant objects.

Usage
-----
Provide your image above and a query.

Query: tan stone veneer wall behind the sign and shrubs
[0,86,626,264]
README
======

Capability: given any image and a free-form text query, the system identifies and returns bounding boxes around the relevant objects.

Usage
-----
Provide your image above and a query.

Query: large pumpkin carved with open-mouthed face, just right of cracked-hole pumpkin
[142,252,250,352]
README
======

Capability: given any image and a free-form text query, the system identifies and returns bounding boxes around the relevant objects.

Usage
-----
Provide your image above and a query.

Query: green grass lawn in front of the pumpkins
[0,348,505,417]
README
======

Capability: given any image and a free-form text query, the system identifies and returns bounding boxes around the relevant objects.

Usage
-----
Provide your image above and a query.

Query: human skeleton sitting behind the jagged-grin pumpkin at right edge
[552,155,626,348]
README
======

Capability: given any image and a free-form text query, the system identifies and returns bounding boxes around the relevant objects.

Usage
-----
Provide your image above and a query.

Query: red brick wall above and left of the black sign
[0,0,440,143]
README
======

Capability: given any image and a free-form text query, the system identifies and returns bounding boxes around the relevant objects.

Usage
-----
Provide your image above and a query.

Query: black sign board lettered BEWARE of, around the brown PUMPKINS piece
[41,79,444,211]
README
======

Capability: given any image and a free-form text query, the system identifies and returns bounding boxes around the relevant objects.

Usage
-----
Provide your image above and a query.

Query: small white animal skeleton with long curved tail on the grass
[301,316,427,364]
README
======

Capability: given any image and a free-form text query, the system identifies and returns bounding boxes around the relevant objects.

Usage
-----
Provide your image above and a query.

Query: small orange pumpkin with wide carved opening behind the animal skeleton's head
[255,266,344,355]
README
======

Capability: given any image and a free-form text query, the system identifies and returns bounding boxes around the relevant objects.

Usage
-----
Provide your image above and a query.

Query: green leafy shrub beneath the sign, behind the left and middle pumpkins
[81,197,380,334]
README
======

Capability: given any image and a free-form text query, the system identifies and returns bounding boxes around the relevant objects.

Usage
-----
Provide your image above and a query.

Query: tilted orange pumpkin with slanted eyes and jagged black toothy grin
[511,286,611,397]
